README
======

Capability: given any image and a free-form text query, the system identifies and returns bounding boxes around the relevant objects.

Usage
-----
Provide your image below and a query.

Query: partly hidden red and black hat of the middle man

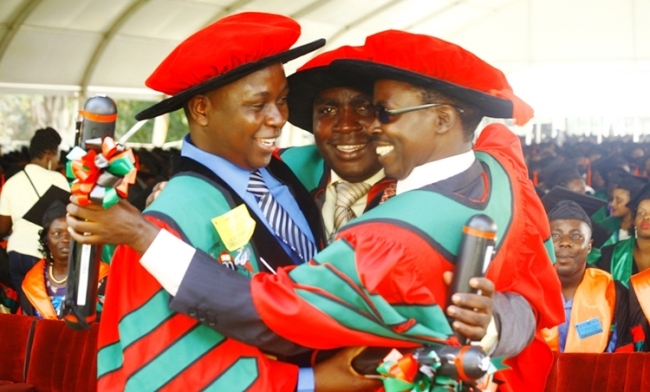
[287,46,373,132]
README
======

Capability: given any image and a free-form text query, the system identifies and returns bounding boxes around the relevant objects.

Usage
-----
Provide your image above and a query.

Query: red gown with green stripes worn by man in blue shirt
[97,175,298,392]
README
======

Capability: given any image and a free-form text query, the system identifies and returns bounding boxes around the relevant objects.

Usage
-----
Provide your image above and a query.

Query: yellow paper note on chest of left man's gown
[212,204,255,252]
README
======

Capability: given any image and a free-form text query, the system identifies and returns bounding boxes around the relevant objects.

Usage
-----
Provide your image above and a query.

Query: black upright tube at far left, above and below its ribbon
[62,95,117,329]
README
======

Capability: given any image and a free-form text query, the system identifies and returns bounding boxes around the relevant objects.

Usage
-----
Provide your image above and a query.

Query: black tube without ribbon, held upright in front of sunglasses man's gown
[447,214,497,344]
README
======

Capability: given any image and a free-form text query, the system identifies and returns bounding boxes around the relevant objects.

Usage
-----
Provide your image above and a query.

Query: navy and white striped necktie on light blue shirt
[248,170,316,261]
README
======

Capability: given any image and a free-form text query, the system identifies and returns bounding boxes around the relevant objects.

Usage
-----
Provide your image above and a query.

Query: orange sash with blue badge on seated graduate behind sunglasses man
[542,268,616,353]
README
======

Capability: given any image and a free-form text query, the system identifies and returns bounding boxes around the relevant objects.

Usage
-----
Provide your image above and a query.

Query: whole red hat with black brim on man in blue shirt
[135,12,325,120]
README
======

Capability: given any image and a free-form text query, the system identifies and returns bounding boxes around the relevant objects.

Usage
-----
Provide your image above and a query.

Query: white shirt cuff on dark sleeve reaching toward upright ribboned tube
[140,229,196,295]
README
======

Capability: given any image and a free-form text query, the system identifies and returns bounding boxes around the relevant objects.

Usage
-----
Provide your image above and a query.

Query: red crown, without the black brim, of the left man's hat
[145,12,300,95]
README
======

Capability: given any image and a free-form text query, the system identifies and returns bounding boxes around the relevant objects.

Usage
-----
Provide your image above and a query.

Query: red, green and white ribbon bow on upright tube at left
[66,136,137,208]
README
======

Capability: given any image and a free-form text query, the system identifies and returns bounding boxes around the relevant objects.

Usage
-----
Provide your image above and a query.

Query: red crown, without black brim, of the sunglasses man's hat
[365,30,533,124]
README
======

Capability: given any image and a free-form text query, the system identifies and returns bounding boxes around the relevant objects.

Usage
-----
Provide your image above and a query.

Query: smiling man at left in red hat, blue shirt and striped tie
[71,12,384,391]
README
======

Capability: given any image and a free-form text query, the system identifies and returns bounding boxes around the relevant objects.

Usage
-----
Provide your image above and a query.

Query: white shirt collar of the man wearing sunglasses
[396,150,476,195]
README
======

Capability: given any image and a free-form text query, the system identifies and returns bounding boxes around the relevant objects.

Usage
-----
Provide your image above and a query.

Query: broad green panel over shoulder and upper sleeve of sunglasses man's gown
[348,152,513,257]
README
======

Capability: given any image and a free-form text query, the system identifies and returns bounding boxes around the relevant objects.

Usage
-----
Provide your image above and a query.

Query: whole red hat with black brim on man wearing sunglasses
[332,30,533,125]
